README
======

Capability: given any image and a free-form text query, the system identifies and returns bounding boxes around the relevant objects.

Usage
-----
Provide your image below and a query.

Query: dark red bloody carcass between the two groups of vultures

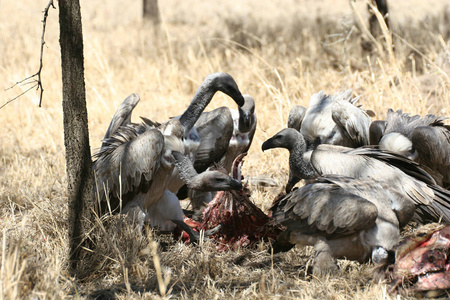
[178,153,283,251]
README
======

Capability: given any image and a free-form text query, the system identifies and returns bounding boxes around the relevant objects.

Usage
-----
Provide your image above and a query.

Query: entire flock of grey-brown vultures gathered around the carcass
[94,73,450,282]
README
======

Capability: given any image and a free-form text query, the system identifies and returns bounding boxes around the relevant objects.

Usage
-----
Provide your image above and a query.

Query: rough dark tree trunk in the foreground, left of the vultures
[59,0,94,274]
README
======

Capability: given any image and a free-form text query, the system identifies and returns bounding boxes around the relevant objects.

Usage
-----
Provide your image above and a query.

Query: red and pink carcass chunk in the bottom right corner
[385,223,450,297]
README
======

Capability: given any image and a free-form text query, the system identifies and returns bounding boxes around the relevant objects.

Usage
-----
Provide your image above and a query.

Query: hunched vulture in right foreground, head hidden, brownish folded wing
[271,175,415,274]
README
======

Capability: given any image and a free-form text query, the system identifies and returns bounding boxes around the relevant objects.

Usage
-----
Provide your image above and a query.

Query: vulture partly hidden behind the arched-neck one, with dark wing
[178,95,257,210]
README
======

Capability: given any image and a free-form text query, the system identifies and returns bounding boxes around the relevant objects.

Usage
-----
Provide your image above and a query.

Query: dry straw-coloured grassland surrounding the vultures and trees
[0,0,450,299]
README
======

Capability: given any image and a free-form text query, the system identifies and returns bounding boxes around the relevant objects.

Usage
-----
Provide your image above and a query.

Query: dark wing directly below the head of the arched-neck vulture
[194,107,234,172]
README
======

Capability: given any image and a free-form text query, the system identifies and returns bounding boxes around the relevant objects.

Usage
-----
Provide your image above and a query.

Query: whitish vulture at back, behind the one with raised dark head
[288,90,371,149]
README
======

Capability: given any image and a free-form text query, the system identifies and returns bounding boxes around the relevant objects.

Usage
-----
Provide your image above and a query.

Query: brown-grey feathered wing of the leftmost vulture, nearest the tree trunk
[94,126,164,212]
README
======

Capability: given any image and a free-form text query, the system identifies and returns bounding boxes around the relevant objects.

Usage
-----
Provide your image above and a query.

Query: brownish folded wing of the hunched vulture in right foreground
[272,182,378,239]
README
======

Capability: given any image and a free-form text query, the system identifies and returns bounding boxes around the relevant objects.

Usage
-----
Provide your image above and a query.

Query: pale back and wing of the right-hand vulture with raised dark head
[311,146,450,222]
